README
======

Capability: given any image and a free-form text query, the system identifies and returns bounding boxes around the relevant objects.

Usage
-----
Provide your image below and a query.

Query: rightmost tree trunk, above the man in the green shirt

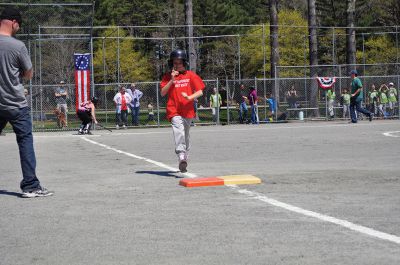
[346,0,356,72]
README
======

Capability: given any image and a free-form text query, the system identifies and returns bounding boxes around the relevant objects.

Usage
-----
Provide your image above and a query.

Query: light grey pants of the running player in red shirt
[171,116,192,156]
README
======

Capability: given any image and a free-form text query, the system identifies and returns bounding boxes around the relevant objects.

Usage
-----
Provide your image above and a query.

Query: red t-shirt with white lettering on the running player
[161,71,205,120]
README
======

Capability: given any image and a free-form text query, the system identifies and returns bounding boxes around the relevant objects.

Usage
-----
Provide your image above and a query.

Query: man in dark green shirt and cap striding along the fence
[350,70,373,123]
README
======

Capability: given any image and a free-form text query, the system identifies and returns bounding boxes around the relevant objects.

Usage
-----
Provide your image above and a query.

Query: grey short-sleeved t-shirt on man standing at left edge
[0,35,32,110]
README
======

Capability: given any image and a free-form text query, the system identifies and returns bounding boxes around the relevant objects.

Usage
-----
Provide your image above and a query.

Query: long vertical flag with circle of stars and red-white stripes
[74,53,90,109]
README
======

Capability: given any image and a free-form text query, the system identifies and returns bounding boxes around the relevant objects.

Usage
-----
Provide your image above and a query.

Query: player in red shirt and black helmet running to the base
[160,49,205,172]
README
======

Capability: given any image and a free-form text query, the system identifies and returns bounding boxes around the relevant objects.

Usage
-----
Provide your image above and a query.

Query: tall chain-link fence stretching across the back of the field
[0,0,400,130]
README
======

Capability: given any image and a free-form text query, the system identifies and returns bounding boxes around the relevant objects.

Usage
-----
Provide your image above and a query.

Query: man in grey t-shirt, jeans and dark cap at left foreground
[0,7,53,198]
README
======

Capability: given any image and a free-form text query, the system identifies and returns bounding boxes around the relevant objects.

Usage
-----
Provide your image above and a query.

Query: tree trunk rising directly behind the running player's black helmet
[185,0,197,72]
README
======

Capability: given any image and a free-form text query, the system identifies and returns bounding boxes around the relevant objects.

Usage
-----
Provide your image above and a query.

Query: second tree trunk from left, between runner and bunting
[269,0,279,102]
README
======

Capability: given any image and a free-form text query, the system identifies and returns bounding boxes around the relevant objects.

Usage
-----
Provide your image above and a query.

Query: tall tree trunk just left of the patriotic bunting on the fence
[308,0,319,117]
